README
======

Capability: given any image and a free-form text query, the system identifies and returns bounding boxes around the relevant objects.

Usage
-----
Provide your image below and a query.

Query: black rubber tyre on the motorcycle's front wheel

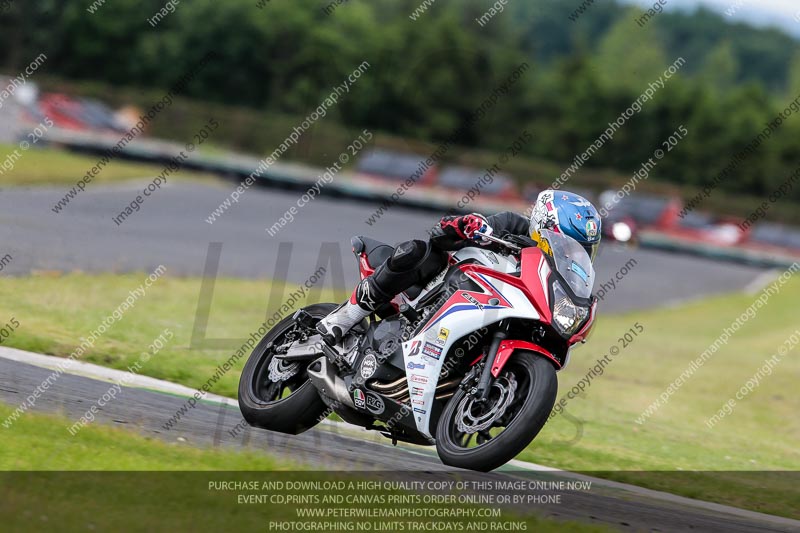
[436,351,558,472]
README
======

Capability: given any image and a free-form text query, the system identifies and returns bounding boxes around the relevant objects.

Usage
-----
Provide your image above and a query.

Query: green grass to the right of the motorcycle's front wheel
[532,280,800,517]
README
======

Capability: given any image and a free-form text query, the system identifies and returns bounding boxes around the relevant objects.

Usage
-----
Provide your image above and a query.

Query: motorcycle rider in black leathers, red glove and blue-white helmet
[317,189,600,347]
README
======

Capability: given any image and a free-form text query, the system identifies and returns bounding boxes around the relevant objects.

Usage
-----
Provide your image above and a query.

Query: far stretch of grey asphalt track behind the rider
[0,181,763,313]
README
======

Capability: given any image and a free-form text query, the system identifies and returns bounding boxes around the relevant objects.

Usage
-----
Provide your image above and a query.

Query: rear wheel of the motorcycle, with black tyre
[239,304,336,435]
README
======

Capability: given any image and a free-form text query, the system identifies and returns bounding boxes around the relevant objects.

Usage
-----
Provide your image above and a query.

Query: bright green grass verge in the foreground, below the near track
[0,404,608,533]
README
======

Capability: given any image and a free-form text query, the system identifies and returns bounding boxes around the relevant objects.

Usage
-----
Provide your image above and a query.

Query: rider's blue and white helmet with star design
[530,189,600,261]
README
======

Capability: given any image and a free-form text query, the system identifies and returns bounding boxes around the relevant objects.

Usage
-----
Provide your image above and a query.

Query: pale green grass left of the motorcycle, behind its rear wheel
[0,273,344,397]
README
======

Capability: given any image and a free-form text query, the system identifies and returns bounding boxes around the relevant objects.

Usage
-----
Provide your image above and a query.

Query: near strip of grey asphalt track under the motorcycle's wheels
[0,358,800,533]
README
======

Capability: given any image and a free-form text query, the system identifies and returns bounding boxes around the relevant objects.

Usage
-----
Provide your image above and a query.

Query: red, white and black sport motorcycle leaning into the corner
[239,230,597,472]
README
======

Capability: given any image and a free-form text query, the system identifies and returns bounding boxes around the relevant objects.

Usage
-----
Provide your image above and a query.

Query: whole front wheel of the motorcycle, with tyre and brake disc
[436,351,558,472]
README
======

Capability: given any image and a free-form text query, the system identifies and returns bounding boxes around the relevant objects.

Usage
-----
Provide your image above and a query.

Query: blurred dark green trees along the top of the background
[0,0,800,199]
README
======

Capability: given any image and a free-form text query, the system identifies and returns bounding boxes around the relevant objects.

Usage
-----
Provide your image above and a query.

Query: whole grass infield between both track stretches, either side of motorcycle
[0,274,800,515]
